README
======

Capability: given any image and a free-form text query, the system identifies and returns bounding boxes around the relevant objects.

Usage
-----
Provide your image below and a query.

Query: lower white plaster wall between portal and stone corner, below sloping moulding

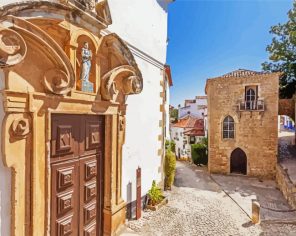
[122,57,162,202]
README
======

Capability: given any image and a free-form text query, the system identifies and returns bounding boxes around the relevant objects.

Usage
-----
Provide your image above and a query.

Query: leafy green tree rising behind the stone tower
[262,0,296,98]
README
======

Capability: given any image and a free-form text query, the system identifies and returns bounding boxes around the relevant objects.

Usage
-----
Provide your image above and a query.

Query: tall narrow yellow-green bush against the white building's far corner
[164,150,176,189]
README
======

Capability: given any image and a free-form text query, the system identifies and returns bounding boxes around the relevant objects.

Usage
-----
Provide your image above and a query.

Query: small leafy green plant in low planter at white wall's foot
[147,180,168,211]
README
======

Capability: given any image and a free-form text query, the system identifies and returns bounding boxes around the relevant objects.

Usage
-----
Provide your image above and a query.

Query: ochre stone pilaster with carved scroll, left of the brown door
[1,113,31,236]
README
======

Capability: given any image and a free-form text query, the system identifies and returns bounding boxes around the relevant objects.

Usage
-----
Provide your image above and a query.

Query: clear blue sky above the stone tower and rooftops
[167,0,293,106]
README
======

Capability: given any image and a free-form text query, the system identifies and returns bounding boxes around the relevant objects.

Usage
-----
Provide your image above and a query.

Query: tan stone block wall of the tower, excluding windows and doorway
[206,74,279,178]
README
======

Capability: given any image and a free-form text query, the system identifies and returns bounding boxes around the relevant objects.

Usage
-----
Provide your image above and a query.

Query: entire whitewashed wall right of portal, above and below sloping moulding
[108,0,169,202]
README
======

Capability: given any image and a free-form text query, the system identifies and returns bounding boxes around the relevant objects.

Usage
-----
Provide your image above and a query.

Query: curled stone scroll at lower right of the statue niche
[101,65,143,101]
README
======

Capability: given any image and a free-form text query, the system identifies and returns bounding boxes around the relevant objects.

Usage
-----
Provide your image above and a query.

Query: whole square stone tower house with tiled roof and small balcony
[206,69,280,178]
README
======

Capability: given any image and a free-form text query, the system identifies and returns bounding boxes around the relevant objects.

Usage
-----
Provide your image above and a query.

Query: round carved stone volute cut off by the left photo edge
[0,27,27,68]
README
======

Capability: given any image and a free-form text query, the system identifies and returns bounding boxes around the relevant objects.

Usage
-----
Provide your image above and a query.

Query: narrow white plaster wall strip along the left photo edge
[0,70,11,236]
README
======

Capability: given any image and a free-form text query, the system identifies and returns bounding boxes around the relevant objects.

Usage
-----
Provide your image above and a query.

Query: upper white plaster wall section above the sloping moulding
[108,0,167,64]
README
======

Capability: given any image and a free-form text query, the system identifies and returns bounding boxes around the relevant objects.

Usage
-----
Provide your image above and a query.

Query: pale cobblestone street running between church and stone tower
[122,162,296,236]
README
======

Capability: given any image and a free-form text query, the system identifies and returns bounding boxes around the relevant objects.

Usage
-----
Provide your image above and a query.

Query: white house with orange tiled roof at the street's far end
[171,115,205,159]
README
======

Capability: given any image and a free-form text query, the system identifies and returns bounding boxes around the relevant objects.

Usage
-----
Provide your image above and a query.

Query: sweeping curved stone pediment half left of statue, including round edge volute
[0,15,75,95]
